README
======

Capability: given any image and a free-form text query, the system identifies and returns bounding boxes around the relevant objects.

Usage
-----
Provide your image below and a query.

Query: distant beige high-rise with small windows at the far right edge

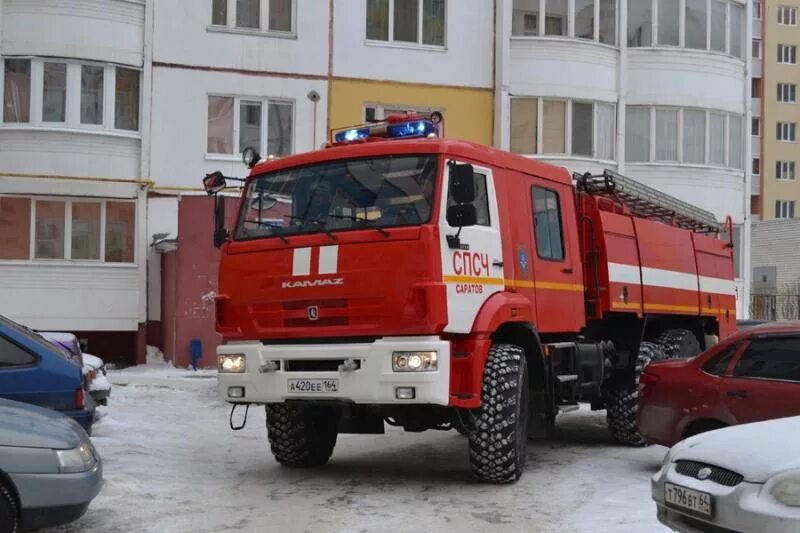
[752,0,800,220]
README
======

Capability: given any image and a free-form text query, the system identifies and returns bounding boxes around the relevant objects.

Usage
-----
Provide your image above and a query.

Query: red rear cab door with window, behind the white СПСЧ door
[532,180,585,333]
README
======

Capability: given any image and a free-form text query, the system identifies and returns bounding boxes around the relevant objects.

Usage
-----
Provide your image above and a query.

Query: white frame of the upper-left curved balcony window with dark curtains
[0,56,144,138]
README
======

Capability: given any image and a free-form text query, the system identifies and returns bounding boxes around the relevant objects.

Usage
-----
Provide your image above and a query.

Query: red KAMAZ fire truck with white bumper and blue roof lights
[204,112,736,483]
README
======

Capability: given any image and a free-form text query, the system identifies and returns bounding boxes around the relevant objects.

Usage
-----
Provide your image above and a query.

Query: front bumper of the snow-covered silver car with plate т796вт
[652,463,800,533]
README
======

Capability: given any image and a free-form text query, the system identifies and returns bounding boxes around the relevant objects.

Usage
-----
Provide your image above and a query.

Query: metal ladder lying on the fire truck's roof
[572,170,722,233]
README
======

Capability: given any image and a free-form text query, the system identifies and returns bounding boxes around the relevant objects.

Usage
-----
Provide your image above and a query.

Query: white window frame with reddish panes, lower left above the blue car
[0,194,139,268]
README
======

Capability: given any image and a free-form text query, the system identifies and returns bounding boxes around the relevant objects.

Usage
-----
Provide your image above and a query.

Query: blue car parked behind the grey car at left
[0,315,95,434]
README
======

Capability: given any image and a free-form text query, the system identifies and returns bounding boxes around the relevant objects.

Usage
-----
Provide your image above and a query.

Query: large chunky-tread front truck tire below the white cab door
[469,344,529,483]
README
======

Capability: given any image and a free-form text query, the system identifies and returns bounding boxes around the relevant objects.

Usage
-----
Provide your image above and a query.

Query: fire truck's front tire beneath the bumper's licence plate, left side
[266,403,339,467]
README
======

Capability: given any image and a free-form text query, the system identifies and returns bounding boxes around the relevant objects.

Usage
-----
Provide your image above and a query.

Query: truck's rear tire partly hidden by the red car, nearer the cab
[603,342,664,446]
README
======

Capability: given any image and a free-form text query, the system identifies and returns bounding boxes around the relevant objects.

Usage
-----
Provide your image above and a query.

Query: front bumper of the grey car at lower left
[10,458,103,529]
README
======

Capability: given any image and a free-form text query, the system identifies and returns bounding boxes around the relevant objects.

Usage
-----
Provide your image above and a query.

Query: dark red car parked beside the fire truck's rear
[637,322,800,446]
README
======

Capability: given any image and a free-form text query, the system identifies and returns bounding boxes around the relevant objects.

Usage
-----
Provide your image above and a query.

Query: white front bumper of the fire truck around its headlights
[217,337,450,405]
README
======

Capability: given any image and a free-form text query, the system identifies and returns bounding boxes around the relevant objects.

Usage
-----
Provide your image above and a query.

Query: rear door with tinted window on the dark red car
[720,335,800,424]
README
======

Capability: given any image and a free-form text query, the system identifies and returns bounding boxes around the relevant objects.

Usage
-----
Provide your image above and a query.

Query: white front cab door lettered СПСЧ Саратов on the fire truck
[439,161,504,333]
